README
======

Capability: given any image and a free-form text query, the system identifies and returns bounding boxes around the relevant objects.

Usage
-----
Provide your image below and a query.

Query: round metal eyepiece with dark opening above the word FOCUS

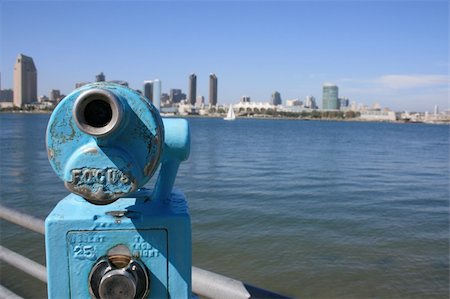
[73,88,123,137]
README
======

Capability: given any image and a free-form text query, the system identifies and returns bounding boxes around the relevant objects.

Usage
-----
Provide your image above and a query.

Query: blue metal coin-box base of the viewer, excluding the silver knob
[45,190,192,299]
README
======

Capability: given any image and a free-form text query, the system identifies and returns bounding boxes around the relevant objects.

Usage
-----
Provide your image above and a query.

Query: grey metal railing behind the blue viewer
[0,205,288,299]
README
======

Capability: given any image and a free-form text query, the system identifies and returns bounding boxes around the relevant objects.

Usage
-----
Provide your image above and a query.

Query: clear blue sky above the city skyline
[0,0,449,111]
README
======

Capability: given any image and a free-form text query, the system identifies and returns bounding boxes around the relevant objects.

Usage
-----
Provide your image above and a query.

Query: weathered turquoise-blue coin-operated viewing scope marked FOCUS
[45,82,192,299]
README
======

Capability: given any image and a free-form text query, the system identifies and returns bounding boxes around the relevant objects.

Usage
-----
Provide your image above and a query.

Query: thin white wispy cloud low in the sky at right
[375,75,450,89]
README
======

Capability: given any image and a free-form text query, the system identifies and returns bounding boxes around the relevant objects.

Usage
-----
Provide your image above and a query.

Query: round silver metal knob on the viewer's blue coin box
[89,256,150,299]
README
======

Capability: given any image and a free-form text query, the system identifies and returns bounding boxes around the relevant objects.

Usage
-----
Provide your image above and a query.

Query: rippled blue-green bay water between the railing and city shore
[0,114,449,298]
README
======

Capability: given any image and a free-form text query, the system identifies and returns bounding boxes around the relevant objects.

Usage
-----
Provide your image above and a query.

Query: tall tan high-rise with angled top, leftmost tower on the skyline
[14,54,37,107]
